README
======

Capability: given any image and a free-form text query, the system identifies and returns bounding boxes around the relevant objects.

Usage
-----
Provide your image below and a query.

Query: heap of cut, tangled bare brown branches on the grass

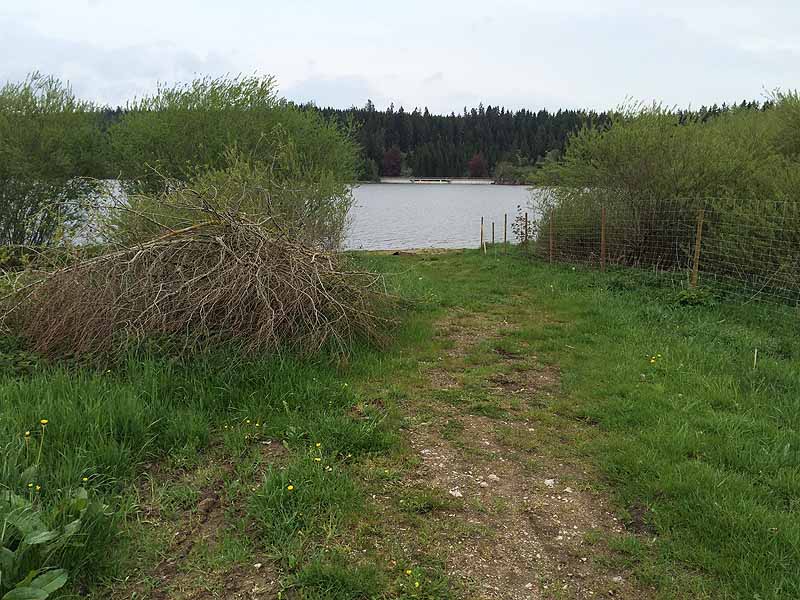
[3,205,392,357]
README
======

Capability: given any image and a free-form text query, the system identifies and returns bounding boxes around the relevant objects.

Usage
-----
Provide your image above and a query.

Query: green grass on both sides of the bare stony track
[0,246,800,599]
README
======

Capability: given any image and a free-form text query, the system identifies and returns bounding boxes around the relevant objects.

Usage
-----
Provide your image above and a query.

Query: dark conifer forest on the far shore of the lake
[316,101,765,183]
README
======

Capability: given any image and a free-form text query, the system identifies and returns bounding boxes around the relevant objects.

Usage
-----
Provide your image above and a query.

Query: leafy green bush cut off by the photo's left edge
[0,73,104,245]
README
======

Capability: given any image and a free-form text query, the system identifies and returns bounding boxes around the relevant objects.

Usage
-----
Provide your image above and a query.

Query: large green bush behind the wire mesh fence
[534,103,800,299]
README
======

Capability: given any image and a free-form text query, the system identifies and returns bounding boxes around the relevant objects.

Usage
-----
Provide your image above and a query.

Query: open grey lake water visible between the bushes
[345,183,531,250]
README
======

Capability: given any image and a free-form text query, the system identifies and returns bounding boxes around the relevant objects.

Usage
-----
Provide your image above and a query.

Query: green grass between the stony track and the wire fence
[366,247,800,598]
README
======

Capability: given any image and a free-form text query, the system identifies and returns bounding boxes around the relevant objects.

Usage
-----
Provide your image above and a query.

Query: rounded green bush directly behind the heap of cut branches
[110,77,358,247]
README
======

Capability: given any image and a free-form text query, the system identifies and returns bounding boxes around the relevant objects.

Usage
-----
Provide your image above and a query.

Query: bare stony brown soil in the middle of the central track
[410,318,651,600]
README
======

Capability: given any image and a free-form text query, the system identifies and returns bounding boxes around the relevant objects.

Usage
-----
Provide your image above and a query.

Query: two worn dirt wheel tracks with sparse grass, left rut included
[98,312,654,600]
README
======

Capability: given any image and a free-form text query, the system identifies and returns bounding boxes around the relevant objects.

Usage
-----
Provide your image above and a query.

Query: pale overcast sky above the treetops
[0,0,800,112]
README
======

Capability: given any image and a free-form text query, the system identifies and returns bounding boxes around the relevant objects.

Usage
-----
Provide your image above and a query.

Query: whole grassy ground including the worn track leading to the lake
[0,247,800,599]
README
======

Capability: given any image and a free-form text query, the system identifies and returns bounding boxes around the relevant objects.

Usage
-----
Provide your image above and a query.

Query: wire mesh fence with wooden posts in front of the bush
[488,195,800,310]
